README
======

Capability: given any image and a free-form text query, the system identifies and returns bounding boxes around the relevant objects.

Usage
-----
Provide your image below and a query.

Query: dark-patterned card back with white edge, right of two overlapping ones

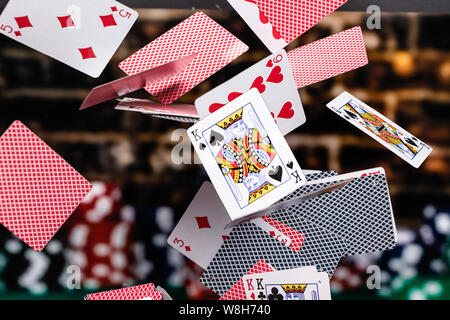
[270,168,397,256]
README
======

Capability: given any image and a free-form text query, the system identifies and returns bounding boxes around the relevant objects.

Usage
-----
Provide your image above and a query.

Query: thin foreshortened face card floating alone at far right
[327,92,433,168]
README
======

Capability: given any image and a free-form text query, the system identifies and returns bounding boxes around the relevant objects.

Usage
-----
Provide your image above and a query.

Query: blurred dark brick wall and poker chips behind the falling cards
[0,1,450,299]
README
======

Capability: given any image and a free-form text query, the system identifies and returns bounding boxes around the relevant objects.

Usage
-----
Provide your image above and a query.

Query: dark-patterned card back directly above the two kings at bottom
[200,219,346,295]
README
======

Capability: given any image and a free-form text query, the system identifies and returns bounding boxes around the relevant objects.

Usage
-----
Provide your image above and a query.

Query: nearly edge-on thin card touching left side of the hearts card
[115,98,199,122]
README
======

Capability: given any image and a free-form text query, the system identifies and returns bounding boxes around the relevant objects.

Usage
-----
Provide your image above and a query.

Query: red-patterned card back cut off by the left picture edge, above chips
[0,121,92,251]
